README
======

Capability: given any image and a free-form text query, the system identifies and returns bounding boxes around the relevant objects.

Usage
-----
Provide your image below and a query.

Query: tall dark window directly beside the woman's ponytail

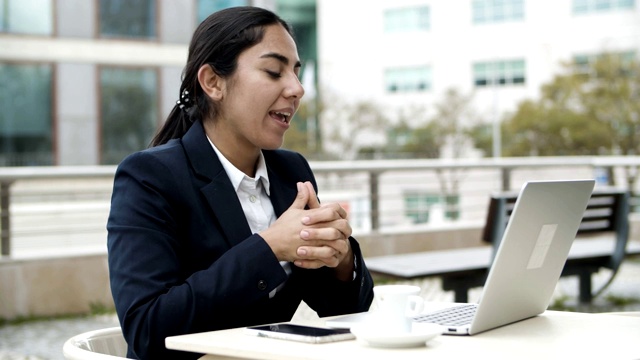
[100,67,158,165]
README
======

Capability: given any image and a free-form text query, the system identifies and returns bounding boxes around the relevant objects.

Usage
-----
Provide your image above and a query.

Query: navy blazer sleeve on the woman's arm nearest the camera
[107,152,286,359]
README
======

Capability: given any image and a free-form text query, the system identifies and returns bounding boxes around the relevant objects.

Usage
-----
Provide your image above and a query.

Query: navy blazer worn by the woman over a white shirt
[107,121,373,359]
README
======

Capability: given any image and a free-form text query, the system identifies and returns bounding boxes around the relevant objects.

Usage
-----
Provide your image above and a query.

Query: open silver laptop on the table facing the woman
[328,179,595,335]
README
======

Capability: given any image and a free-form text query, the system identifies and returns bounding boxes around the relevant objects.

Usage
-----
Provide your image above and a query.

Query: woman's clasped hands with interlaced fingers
[260,181,353,274]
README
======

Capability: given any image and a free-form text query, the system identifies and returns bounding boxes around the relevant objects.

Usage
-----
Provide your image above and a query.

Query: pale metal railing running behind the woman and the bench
[0,156,640,257]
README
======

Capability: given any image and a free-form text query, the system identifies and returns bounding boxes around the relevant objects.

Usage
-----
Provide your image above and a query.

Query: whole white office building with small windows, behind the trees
[317,0,640,155]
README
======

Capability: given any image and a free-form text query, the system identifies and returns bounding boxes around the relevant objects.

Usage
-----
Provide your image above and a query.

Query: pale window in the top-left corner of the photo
[0,0,53,35]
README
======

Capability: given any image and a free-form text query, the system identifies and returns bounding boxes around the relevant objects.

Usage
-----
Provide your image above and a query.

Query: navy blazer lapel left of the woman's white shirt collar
[182,121,252,247]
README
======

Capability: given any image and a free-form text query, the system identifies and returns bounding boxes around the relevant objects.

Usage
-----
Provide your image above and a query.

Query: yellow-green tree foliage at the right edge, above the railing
[500,54,640,156]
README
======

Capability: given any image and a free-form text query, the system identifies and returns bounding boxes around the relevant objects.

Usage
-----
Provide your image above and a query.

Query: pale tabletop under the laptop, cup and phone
[166,311,640,360]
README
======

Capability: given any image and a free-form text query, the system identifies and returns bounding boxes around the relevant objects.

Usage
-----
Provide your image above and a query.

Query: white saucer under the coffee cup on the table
[351,323,444,348]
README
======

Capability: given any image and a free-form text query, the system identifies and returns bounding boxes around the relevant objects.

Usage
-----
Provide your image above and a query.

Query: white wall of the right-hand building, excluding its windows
[318,0,640,127]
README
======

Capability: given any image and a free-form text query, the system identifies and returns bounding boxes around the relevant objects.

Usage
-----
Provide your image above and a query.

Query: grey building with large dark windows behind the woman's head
[0,0,316,166]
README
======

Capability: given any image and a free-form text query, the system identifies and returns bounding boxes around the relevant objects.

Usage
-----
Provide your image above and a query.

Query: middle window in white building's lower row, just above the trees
[473,60,526,87]
